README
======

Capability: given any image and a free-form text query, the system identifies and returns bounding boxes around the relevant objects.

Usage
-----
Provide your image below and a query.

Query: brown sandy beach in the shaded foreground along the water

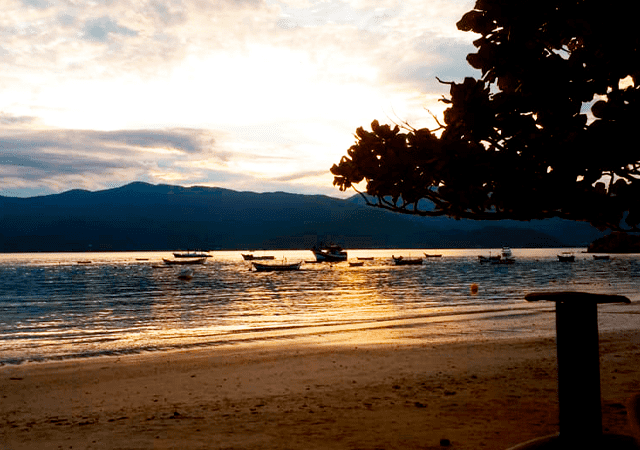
[0,331,640,450]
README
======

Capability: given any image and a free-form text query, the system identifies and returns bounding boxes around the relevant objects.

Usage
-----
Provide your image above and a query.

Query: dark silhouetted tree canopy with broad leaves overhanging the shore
[331,0,640,231]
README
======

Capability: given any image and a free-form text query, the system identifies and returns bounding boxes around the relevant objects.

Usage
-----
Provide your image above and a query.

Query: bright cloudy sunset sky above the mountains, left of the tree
[0,0,478,197]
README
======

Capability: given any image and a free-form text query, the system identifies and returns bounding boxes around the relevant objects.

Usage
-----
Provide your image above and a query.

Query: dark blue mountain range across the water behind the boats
[0,182,602,252]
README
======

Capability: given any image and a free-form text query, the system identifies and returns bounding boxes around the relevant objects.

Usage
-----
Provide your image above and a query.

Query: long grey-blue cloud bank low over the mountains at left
[0,129,228,190]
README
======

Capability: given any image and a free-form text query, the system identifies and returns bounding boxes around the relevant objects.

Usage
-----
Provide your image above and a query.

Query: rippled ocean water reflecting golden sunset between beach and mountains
[0,249,640,365]
